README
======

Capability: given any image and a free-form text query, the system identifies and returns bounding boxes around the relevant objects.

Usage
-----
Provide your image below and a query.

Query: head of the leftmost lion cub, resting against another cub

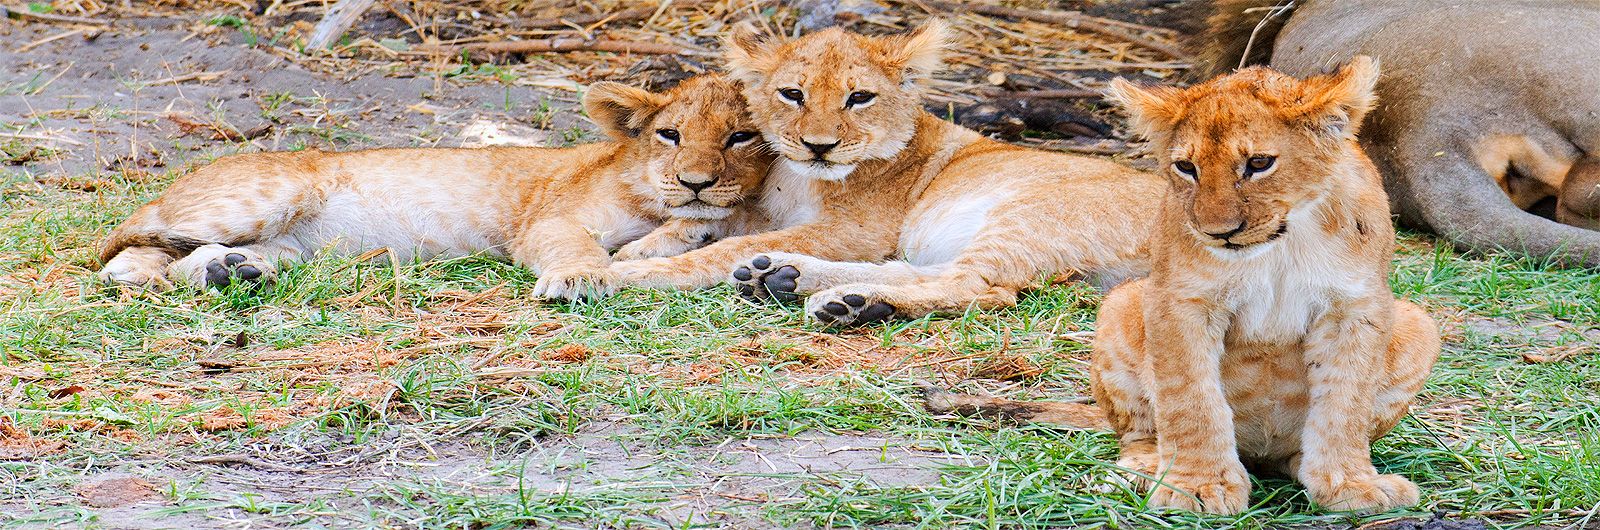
[584,75,773,219]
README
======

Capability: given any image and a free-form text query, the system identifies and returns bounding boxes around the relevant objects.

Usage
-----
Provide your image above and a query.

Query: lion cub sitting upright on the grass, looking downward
[1091,56,1440,514]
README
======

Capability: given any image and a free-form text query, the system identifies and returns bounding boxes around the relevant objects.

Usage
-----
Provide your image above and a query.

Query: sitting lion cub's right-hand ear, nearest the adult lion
[1294,54,1378,139]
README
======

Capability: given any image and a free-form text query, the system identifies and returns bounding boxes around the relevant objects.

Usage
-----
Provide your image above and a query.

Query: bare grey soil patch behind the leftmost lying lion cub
[0,19,581,178]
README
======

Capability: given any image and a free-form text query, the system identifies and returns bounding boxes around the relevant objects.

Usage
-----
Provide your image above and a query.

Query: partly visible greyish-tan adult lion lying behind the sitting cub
[1205,0,1600,266]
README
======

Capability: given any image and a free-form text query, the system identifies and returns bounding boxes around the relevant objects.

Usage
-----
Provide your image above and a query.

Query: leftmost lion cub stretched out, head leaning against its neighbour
[99,75,771,298]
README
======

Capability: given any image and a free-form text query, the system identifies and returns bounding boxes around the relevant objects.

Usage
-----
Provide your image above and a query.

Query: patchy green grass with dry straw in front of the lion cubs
[0,160,1600,528]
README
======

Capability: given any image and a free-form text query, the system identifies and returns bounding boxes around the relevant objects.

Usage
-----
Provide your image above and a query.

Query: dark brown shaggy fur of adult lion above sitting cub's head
[1192,0,1307,78]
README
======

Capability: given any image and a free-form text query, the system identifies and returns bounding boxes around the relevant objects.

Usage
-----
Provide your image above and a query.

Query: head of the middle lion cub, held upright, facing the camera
[726,19,946,181]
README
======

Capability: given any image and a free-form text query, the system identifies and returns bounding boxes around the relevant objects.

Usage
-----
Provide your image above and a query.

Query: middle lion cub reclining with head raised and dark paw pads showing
[613,21,1163,325]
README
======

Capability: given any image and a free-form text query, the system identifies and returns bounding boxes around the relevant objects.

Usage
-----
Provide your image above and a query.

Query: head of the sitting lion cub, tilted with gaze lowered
[1107,56,1378,251]
